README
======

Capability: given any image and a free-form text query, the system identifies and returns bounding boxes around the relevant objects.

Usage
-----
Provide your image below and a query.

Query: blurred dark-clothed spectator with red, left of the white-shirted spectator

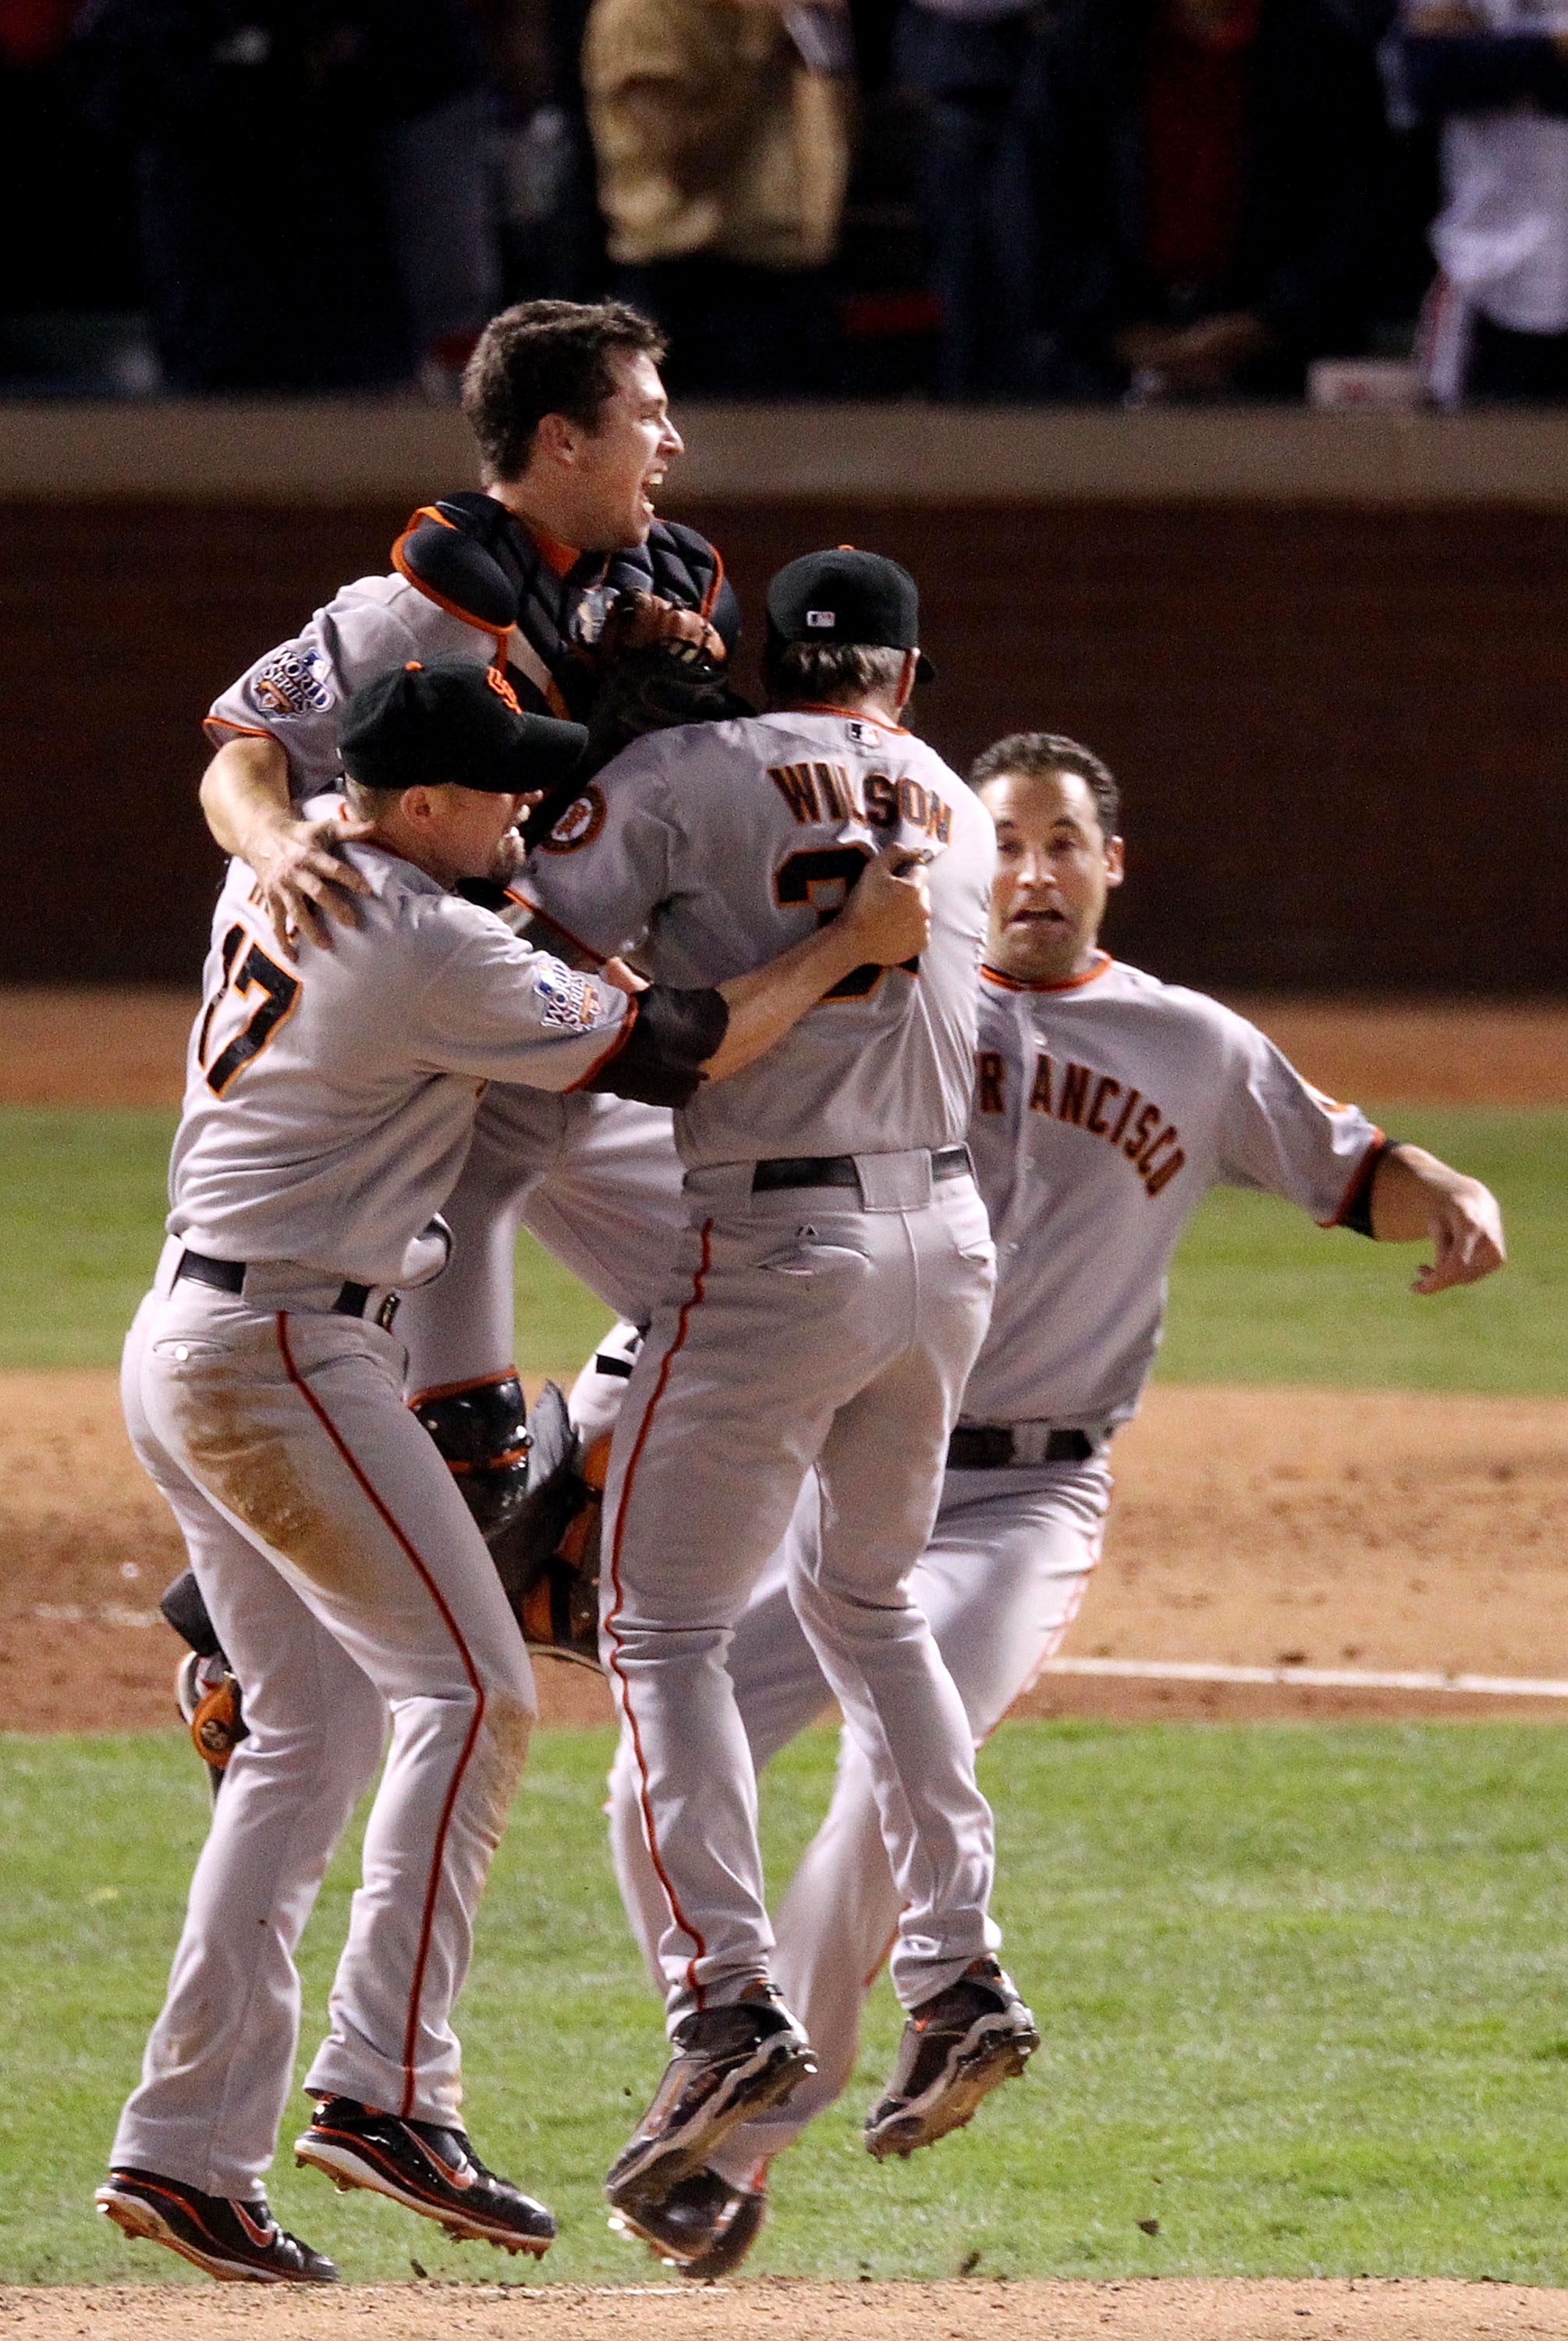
[1037,0,1388,400]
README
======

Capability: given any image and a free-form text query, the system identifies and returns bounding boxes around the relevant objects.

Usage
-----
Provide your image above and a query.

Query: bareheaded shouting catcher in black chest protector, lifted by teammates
[201,302,744,1529]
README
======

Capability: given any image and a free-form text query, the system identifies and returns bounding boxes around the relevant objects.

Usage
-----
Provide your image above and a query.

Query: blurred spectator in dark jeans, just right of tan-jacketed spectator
[894,0,1058,400]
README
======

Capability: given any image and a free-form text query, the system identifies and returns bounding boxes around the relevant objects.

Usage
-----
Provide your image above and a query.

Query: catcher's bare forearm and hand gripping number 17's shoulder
[201,733,370,957]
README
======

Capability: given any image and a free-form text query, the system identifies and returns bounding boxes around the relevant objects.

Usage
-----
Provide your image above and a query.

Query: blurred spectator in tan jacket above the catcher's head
[583,0,850,398]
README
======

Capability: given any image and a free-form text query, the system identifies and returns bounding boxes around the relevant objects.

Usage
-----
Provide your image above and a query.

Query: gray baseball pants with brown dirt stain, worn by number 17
[112,1243,536,2198]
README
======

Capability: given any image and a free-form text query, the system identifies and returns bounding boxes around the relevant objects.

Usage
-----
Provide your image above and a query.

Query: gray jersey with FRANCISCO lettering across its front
[962,955,1381,1426]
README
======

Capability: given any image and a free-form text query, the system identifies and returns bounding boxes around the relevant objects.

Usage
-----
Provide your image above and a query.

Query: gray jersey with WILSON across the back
[524,709,995,1166]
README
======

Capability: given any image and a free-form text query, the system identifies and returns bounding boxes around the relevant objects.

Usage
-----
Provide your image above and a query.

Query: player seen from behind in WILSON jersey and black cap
[529,548,1037,2215]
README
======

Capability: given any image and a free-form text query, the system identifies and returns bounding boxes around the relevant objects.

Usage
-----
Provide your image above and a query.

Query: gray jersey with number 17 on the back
[169,845,627,1285]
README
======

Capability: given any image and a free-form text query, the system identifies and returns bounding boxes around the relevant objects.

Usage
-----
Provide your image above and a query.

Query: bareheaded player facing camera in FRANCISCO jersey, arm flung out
[604,733,1502,2275]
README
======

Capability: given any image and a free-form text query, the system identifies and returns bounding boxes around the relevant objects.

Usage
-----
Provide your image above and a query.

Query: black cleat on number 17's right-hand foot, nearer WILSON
[295,2098,555,2259]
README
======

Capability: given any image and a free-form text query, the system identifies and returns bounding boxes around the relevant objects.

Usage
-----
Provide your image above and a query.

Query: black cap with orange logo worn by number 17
[339,658,587,796]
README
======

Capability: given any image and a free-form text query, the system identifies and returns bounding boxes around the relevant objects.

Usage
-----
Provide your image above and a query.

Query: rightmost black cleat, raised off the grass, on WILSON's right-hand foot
[866,1959,1039,2161]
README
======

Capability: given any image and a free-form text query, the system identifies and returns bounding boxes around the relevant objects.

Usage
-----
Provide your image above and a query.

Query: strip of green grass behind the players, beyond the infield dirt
[0,1107,1568,1395]
